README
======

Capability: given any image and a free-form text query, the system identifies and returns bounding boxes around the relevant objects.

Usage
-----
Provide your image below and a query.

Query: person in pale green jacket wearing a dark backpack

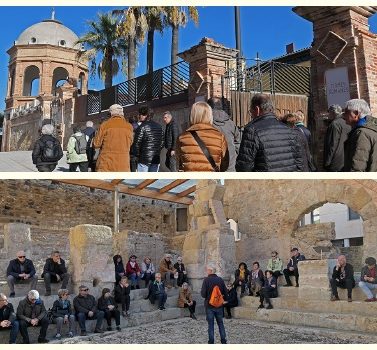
[67,125,89,172]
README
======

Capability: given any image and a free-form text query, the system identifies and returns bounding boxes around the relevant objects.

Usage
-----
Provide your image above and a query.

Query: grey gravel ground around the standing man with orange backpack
[62,316,377,344]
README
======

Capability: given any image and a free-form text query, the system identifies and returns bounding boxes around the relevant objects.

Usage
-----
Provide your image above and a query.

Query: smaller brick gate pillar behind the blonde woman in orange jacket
[178,38,238,106]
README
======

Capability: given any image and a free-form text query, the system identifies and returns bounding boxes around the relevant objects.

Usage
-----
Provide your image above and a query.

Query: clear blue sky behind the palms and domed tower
[0,6,377,110]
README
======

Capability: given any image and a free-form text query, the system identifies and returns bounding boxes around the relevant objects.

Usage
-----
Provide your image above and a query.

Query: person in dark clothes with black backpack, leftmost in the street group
[32,124,63,172]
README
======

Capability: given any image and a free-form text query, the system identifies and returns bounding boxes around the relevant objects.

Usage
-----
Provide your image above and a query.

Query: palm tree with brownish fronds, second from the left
[113,6,148,79]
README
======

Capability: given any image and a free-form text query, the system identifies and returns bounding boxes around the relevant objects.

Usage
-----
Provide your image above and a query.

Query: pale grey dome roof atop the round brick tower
[15,19,80,49]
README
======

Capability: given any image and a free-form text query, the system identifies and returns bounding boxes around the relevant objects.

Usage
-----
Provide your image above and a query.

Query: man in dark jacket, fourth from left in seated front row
[73,285,105,336]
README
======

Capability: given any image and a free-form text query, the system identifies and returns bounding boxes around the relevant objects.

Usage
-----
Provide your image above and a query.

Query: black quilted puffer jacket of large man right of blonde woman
[236,114,304,171]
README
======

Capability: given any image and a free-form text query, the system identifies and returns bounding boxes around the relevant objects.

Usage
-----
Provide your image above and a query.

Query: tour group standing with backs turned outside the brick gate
[32,94,377,172]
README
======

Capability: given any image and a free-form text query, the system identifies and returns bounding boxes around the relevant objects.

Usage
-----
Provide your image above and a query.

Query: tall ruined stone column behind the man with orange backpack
[183,180,236,291]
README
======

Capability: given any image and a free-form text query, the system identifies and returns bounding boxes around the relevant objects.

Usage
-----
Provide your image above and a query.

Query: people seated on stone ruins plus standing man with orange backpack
[0,248,377,344]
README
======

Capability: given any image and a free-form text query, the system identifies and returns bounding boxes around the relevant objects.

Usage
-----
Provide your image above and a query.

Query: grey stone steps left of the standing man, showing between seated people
[0,288,204,344]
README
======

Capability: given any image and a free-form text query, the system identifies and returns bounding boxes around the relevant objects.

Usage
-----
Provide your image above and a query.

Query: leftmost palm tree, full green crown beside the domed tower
[76,13,127,89]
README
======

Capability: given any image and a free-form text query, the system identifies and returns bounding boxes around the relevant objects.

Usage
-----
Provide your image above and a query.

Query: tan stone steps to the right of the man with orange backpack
[233,287,377,332]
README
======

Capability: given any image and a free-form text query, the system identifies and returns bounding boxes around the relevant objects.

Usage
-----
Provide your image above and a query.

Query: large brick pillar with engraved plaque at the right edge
[293,6,377,169]
